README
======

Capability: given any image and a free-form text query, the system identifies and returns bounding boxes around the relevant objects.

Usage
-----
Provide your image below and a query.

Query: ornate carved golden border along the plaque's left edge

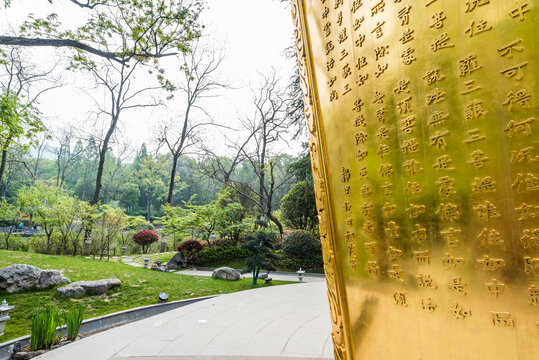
[290,0,348,360]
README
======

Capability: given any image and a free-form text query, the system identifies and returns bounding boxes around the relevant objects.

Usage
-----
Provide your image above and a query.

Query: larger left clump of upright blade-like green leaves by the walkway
[30,305,61,351]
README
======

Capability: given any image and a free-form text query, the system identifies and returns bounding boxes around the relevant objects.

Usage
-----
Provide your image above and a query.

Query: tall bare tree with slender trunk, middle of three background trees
[158,41,228,204]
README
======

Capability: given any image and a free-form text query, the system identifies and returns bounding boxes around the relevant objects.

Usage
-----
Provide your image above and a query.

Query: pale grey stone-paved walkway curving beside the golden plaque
[36,282,333,360]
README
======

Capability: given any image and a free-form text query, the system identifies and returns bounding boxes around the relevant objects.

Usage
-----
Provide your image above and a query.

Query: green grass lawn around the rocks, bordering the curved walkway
[0,250,287,342]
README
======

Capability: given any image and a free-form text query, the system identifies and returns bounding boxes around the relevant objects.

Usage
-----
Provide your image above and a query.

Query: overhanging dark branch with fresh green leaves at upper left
[0,0,202,64]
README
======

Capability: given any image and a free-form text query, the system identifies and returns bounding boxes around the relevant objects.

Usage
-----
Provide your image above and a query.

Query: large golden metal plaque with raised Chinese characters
[292,0,539,360]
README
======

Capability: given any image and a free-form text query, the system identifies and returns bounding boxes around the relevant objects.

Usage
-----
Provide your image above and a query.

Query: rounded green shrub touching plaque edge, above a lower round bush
[281,182,318,231]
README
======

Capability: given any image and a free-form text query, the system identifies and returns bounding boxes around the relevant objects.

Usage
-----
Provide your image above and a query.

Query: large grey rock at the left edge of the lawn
[0,264,71,293]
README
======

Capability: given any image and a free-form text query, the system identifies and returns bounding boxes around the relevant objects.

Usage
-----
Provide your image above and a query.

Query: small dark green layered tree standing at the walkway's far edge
[241,231,281,285]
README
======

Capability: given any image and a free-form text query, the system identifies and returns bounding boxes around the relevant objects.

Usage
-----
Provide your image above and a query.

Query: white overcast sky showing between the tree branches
[0,0,299,158]
